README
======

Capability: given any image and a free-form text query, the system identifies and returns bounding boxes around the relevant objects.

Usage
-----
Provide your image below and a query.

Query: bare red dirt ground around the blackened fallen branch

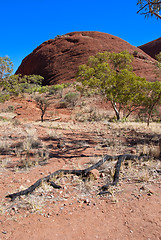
[0,96,161,240]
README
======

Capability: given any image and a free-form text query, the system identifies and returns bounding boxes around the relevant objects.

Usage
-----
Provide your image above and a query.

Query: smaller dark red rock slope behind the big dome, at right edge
[138,37,161,58]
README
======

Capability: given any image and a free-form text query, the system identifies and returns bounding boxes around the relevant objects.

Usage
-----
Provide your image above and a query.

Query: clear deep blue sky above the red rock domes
[0,0,161,71]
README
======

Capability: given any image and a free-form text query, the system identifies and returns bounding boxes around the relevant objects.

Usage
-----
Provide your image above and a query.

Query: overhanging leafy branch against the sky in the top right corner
[137,0,161,19]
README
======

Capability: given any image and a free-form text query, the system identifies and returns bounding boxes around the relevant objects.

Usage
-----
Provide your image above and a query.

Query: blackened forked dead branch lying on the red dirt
[6,154,148,201]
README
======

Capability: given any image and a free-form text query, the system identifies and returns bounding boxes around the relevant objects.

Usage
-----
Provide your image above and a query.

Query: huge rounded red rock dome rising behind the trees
[16,31,159,85]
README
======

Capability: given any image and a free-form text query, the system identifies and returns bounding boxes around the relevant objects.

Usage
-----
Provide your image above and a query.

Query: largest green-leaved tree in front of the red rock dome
[77,51,146,120]
